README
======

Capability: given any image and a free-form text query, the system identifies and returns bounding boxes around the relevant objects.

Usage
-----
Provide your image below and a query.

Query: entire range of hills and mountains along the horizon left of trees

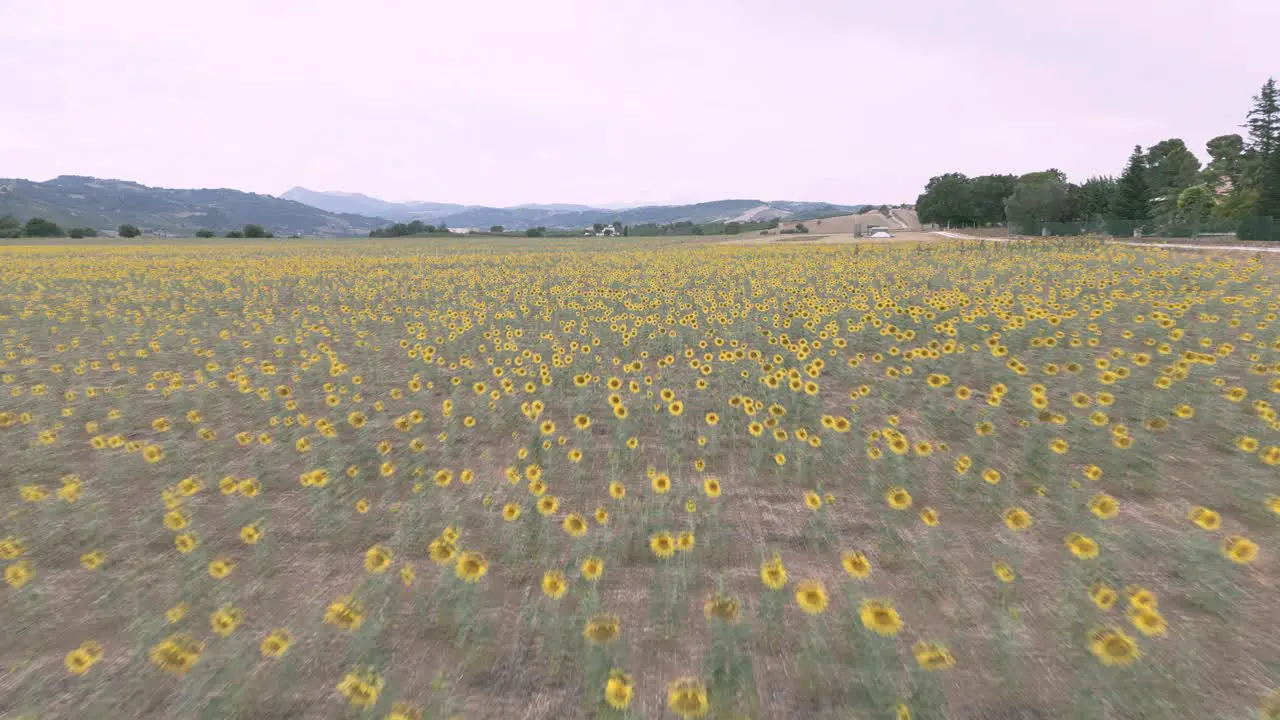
[0,176,868,237]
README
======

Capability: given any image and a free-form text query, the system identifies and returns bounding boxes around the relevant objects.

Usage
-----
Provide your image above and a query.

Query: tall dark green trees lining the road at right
[915,78,1280,240]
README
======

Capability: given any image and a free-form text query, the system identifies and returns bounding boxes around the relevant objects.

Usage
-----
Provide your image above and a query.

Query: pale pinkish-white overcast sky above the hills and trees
[0,0,1280,205]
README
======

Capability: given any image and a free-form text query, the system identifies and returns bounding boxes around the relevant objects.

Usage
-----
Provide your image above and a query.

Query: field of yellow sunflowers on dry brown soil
[0,238,1280,720]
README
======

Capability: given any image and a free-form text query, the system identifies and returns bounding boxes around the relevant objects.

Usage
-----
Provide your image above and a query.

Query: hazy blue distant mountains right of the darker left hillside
[288,187,867,229]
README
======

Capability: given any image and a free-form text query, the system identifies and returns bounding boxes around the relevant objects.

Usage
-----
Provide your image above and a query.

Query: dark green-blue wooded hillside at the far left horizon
[0,176,387,237]
